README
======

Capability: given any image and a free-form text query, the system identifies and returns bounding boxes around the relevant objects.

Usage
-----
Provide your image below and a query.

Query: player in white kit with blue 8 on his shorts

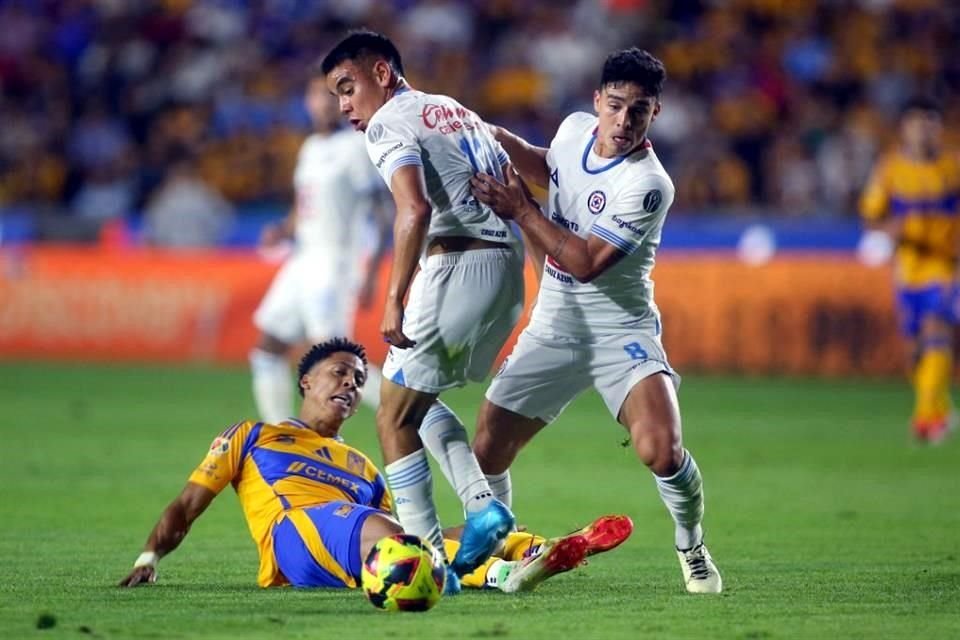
[473,48,722,593]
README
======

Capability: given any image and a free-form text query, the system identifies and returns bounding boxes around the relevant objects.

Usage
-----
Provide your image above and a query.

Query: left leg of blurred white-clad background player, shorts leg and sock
[250,256,304,423]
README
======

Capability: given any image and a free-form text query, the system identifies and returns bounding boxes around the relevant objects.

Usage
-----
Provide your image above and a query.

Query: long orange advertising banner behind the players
[0,247,901,375]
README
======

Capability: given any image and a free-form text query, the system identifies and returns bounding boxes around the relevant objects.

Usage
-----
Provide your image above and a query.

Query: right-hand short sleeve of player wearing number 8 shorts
[587,176,674,255]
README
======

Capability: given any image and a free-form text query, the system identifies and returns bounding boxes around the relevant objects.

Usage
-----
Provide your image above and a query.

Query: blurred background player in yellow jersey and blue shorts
[860,97,960,442]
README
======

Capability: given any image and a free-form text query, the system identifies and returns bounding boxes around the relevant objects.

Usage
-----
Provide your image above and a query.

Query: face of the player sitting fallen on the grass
[300,351,367,422]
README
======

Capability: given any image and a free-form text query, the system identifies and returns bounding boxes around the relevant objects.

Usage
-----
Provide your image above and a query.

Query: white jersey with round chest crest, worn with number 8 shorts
[530,113,674,338]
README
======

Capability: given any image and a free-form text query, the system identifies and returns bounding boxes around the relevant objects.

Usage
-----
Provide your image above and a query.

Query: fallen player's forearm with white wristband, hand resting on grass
[119,482,217,587]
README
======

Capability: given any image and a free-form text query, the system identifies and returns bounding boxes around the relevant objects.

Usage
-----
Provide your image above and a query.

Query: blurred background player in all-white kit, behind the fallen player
[250,66,390,423]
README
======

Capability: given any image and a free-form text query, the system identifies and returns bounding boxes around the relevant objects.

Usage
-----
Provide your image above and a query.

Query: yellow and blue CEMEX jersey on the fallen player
[190,419,392,587]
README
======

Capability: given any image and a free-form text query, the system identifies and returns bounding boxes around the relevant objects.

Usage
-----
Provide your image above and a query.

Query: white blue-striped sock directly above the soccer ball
[385,449,446,558]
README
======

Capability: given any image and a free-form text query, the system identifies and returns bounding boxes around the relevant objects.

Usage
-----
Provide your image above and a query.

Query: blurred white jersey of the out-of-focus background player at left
[293,130,378,254]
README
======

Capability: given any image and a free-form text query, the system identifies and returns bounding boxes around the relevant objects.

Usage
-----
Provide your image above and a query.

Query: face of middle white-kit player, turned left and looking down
[327,58,393,131]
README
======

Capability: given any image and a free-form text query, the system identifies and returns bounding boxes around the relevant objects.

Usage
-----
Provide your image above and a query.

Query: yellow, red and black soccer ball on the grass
[361,533,447,611]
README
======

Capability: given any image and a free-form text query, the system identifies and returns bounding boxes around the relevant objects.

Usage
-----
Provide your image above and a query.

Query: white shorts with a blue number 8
[487,327,680,423]
